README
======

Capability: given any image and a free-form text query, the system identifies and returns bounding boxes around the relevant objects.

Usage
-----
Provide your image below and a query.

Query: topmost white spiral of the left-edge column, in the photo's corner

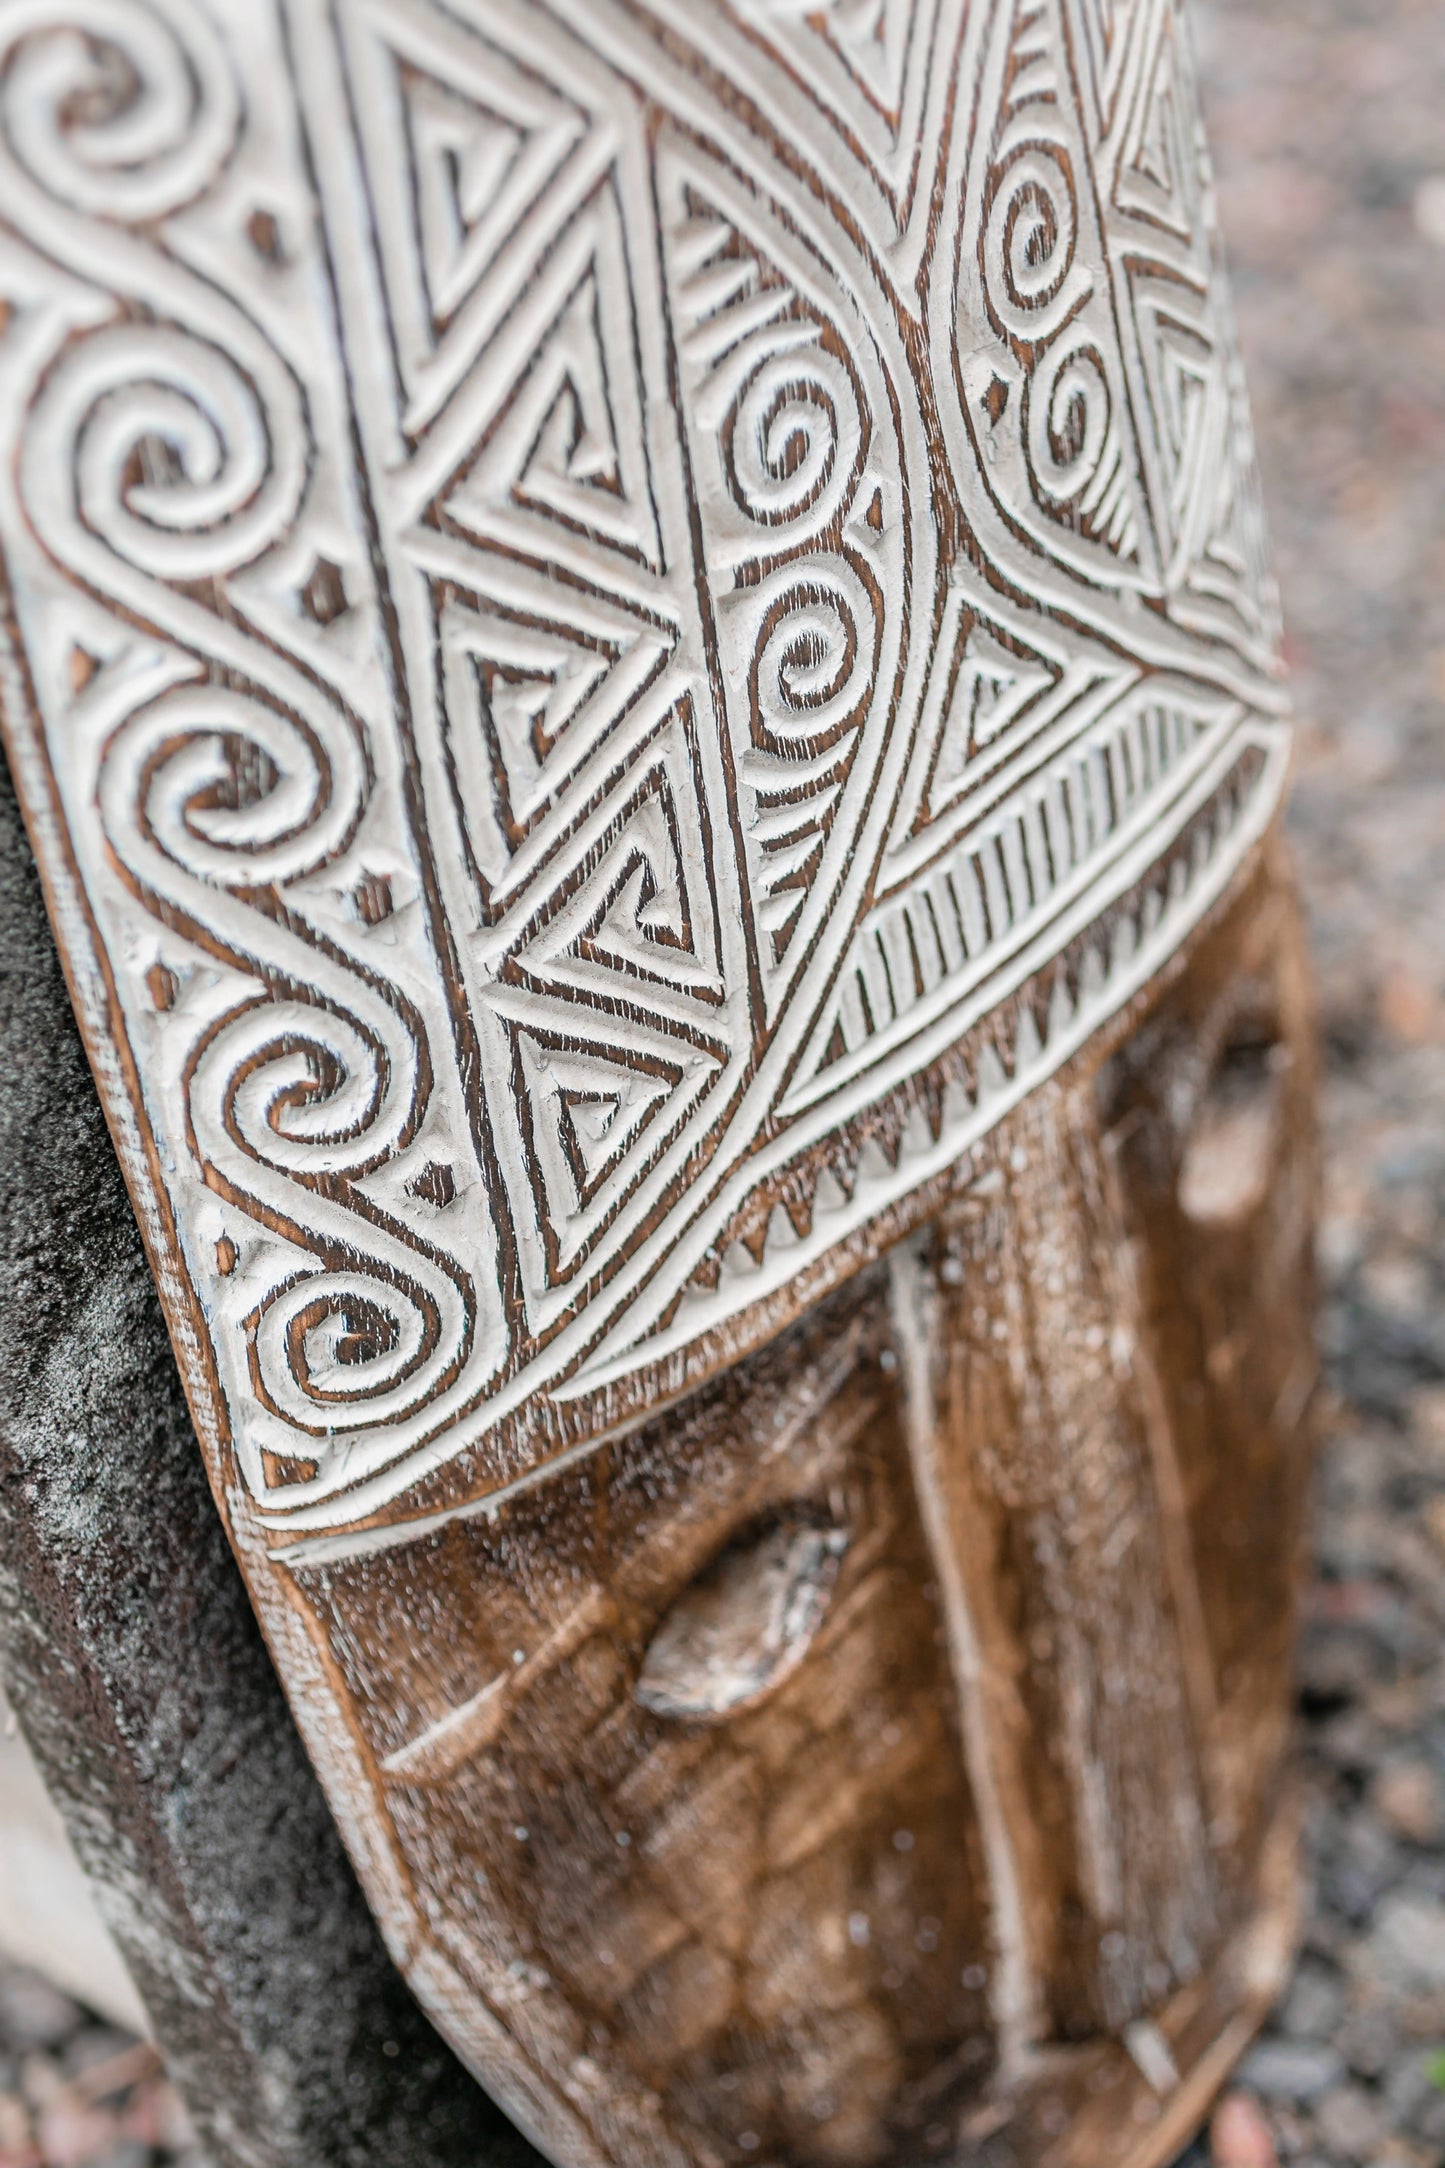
[0,0,240,225]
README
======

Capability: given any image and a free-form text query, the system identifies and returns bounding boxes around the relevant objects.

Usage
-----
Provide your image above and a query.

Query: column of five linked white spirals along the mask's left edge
[0,21,477,1437]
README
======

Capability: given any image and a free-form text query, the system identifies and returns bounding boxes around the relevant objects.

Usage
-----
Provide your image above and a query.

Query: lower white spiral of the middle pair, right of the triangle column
[750,555,882,757]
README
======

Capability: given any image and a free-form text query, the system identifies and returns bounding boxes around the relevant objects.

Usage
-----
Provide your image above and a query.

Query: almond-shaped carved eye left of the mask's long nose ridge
[637,1513,849,1724]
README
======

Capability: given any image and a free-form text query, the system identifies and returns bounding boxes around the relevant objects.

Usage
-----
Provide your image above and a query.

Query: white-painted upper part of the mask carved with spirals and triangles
[0,0,1285,1531]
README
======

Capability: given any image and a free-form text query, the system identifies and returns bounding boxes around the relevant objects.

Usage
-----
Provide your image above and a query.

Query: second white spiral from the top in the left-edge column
[22,323,308,583]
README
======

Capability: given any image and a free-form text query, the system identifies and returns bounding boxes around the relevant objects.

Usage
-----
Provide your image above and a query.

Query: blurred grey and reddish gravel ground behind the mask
[0,0,1445,2168]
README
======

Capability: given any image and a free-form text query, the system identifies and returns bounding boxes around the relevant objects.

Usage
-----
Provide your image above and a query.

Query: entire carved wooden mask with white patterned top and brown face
[0,0,1306,2168]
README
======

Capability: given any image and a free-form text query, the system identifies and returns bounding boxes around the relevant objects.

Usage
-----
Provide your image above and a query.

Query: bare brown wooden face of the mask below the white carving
[254,848,1315,2168]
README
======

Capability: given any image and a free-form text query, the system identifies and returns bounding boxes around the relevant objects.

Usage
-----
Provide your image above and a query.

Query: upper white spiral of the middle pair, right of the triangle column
[721,325,867,527]
